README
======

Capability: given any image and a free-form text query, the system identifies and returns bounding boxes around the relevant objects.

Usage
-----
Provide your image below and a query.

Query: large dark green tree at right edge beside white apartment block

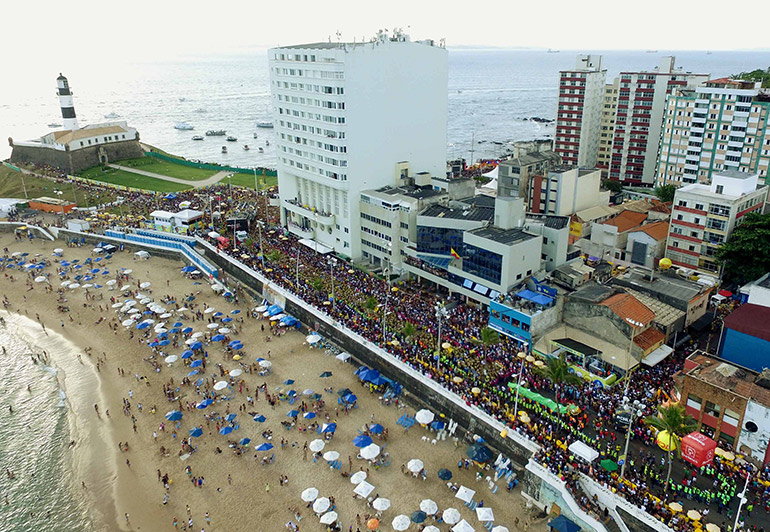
[716,213,770,283]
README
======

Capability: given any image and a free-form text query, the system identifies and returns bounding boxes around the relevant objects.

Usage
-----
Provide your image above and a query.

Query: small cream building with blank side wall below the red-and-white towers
[526,166,610,216]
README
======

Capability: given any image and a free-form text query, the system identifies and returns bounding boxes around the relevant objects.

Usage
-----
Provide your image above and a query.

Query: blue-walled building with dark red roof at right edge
[719,303,770,372]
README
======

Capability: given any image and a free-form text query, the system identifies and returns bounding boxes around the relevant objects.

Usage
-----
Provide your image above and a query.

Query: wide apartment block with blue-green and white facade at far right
[656,78,770,185]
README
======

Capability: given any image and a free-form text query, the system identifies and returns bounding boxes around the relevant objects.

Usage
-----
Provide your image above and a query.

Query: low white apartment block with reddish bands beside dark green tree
[666,170,768,274]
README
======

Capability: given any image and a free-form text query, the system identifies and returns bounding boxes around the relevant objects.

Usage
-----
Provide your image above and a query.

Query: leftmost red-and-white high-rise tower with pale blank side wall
[554,55,607,168]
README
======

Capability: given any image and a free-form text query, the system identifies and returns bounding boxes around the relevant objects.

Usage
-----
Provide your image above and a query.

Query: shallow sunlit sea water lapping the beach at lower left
[0,314,93,532]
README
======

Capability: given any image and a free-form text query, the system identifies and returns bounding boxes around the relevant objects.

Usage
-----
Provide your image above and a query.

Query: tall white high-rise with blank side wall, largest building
[268,31,447,260]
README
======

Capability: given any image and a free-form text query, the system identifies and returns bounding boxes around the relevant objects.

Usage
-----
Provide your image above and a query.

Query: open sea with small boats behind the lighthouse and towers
[0,49,770,167]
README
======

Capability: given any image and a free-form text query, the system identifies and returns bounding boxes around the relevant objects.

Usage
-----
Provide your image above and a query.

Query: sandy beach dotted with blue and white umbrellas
[0,234,544,532]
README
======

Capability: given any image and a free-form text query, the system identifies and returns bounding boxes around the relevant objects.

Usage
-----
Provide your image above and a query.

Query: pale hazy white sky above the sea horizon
[0,0,770,69]
